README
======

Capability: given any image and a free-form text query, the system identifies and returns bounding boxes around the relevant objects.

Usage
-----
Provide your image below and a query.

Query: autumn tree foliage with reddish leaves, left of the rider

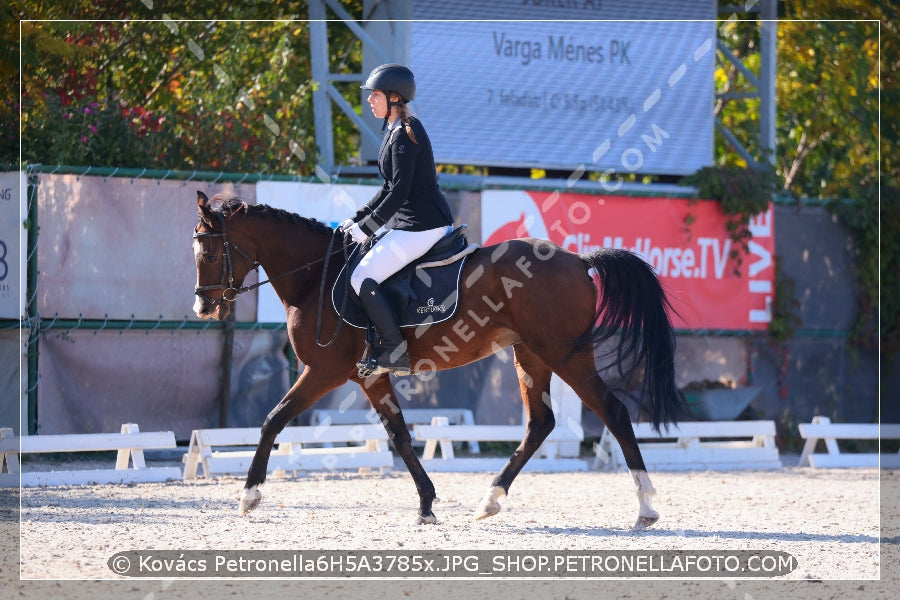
[0,0,362,175]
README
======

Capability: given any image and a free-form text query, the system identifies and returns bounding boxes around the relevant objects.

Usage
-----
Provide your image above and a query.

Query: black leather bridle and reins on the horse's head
[194,212,350,348]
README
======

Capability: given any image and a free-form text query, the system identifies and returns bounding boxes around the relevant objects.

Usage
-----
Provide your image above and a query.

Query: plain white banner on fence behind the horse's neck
[256,181,379,323]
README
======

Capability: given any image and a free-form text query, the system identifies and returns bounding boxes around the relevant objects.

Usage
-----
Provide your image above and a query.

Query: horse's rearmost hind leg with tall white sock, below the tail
[557,353,659,529]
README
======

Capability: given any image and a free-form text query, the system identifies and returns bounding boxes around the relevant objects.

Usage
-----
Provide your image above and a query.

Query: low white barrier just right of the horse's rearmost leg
[594,421,782,471]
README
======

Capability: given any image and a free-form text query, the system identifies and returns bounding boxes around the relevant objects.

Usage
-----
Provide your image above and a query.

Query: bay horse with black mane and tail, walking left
[193,191,684,528]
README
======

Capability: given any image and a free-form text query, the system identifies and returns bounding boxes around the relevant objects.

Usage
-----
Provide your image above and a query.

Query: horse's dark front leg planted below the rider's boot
[360,375,437,524]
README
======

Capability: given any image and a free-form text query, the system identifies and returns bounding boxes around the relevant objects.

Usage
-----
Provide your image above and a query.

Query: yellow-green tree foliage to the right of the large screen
[716,0,900,347]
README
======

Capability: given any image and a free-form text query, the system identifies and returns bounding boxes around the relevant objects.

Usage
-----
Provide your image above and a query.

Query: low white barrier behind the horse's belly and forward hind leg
[413,417,588,472]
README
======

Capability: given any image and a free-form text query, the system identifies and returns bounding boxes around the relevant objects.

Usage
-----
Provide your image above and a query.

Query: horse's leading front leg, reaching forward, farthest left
[239,365,346,515]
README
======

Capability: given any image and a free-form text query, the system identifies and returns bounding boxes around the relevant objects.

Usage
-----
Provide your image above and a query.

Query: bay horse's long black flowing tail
[583,248,686,431]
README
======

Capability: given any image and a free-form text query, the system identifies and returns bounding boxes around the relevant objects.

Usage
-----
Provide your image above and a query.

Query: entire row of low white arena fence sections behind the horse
[0,415,900,487]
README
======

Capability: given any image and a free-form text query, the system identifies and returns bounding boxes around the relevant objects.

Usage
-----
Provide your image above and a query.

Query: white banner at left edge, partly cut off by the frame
[0,171,28,319]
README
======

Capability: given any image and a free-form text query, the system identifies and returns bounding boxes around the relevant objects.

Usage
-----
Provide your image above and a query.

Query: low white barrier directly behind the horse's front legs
[182,425,394,479]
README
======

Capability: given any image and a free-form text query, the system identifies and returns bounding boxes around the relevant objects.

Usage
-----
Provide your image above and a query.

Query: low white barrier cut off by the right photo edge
[797,417,900,469]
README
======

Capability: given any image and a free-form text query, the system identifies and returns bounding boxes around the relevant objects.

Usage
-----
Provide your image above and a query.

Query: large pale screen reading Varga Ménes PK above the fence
[410,0,716,174]
